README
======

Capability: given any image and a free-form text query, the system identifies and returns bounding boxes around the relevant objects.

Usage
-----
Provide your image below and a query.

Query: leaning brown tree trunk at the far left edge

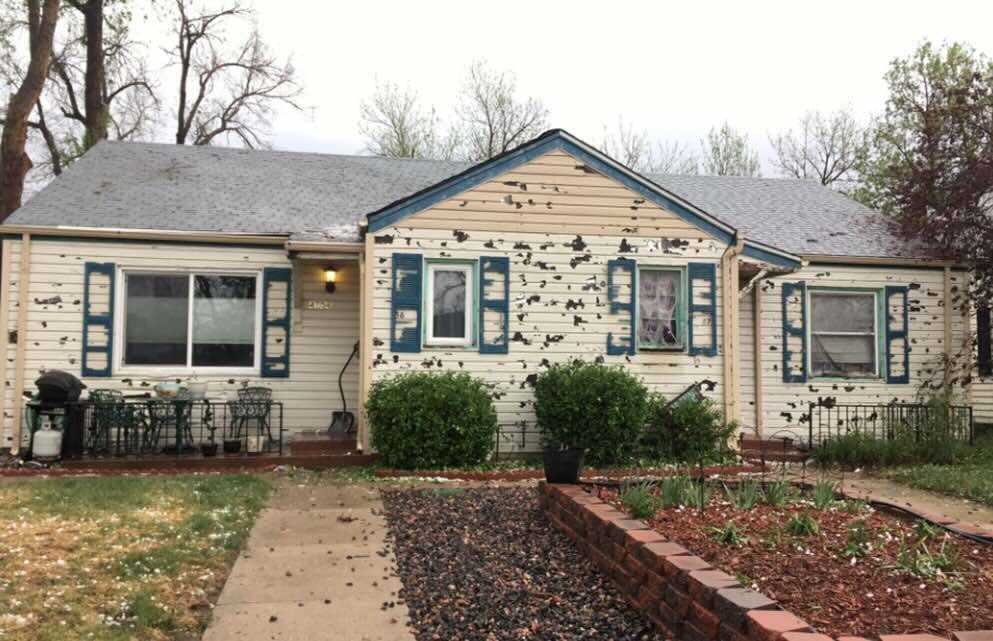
[0,0,59,222]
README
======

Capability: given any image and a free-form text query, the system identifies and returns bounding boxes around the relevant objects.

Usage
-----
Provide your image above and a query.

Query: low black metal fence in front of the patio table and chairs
[25,399,284,458]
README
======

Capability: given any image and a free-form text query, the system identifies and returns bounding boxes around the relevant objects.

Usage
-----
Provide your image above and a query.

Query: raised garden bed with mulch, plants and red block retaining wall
[542,479,993,641]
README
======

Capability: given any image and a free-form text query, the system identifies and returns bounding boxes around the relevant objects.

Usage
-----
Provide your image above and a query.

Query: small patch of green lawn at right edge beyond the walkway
[884,435,993,506]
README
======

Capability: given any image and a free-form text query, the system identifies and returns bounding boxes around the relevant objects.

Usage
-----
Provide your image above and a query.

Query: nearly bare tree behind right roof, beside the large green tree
[769,109,864,186]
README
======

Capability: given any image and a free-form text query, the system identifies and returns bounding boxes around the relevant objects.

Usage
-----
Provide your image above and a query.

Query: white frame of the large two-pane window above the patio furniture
[114,267,264,376]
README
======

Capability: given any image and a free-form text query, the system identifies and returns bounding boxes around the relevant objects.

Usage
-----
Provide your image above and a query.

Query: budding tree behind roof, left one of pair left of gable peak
[359,84,457,158]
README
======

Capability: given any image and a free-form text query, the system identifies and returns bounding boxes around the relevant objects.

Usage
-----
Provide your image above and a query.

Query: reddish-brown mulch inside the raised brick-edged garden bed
[600,487,993,637]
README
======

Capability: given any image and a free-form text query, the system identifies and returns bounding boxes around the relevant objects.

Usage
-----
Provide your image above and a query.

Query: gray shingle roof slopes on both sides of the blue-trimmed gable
[7,142,908,257]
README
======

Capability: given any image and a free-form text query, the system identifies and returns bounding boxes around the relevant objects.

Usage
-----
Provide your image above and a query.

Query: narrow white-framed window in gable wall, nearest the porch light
[424,262,475,347]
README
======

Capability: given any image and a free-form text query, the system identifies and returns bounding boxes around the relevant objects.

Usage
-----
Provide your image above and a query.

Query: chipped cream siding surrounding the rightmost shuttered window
[741,264,967,438]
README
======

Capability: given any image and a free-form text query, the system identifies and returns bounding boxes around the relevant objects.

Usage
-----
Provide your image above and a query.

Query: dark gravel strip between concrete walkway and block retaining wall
[383,488,664,641]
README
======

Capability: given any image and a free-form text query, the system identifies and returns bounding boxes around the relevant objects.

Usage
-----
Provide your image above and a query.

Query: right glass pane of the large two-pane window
[193,276,255,367]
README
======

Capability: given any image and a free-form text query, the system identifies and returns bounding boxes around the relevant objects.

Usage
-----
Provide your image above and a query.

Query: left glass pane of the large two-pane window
[124,274,190,365]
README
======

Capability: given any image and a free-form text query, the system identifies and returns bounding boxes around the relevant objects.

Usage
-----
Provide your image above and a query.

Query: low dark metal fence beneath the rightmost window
[807,402,976,447]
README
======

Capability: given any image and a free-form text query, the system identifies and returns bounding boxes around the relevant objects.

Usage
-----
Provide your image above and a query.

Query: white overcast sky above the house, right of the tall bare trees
[149,0,993,174]
